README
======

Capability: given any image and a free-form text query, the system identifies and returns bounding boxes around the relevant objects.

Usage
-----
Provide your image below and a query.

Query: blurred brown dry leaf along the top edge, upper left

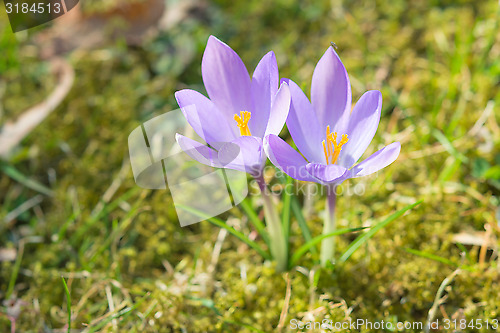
[35,0,203,59]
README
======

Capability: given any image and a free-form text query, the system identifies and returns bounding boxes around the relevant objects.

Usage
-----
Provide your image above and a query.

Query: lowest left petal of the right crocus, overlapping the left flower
[264,134,318,182]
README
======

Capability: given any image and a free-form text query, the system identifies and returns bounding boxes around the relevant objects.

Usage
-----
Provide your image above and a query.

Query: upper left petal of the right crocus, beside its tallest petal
[282,79,326,163]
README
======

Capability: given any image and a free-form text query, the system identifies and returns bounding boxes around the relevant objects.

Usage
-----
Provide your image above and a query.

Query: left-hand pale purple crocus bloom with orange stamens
[175,36,290,175]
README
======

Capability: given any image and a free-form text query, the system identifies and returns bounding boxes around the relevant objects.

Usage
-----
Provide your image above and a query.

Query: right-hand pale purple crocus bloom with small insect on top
[264,47,401,185]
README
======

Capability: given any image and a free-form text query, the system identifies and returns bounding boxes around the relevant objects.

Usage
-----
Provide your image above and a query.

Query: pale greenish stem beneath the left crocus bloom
[255,175,288,272]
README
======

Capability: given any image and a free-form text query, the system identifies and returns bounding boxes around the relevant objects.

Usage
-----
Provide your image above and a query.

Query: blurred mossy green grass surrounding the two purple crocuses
[0,0,500,332]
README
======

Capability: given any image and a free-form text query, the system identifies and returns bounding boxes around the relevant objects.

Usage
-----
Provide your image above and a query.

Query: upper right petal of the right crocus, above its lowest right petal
[338,90,382,168]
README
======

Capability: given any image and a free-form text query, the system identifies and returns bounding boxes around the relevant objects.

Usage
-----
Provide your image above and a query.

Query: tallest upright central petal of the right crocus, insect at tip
[311,46,351,134]
